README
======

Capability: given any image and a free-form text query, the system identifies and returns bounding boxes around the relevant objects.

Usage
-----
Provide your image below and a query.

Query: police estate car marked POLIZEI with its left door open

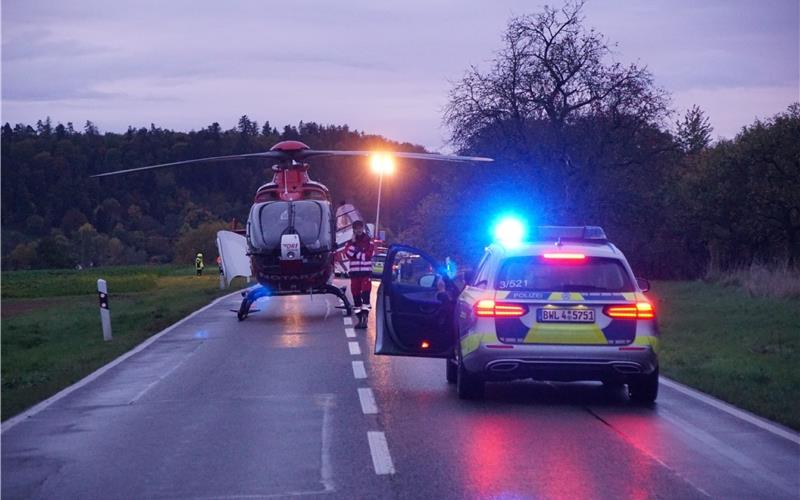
[375,226,658,404]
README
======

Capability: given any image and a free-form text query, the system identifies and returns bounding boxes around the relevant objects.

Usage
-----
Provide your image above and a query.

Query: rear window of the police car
[495,256,634,292]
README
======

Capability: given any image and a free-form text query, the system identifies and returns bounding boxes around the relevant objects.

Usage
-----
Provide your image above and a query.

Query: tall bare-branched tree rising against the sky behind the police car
[444,0,674,227]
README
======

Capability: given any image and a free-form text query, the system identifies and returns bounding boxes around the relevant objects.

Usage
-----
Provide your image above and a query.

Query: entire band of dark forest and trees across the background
[2,2,800,279]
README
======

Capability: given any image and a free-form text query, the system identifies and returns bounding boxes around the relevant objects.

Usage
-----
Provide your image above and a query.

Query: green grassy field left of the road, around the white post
[0,266,244,420]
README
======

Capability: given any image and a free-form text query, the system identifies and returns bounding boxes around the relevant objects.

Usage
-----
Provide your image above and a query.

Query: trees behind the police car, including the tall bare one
[402,2,800,278]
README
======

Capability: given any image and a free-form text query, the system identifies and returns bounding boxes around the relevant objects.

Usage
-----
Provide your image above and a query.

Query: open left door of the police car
[375,245,456,358]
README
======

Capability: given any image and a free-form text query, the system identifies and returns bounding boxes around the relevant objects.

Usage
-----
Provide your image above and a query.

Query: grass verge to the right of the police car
[649,281,800,430]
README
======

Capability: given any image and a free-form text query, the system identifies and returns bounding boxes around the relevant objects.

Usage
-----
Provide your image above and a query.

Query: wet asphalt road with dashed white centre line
[2,284,800,499]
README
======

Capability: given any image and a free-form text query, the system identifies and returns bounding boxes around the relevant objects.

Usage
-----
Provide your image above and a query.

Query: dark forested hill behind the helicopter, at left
[2,115,432,269]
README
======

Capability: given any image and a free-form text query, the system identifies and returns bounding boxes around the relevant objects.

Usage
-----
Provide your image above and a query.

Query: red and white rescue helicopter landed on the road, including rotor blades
[92,141,492,321]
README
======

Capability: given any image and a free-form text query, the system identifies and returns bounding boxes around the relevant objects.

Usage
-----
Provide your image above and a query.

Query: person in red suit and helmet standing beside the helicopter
[344,220,375,328]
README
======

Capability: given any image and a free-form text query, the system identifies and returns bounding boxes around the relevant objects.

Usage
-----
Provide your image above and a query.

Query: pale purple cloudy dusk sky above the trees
[2,0,800,152]
